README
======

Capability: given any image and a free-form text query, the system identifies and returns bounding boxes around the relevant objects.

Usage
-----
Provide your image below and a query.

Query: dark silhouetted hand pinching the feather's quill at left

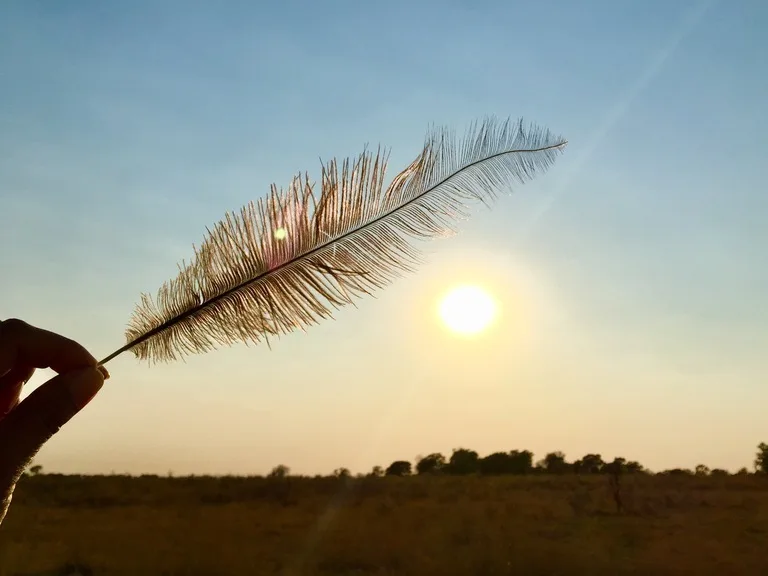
[0,319,109,522]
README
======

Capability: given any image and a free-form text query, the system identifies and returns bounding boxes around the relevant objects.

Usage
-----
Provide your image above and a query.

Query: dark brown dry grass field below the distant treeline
[0,475,768,576]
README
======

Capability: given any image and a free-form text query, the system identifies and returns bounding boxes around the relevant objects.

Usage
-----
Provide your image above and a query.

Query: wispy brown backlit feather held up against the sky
[101,118,566,364]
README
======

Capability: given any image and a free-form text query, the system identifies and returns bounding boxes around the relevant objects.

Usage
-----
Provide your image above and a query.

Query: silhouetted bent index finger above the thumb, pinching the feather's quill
[0,318,109,378]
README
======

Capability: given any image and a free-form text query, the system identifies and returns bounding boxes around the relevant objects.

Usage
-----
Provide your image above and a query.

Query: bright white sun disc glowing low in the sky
[438,285,496,336]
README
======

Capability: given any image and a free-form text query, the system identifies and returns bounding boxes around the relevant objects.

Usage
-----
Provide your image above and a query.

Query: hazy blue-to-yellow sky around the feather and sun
[0,0,768,474]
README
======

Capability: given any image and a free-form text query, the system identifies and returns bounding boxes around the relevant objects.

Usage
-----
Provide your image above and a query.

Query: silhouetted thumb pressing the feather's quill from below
[0,367,104,483]
